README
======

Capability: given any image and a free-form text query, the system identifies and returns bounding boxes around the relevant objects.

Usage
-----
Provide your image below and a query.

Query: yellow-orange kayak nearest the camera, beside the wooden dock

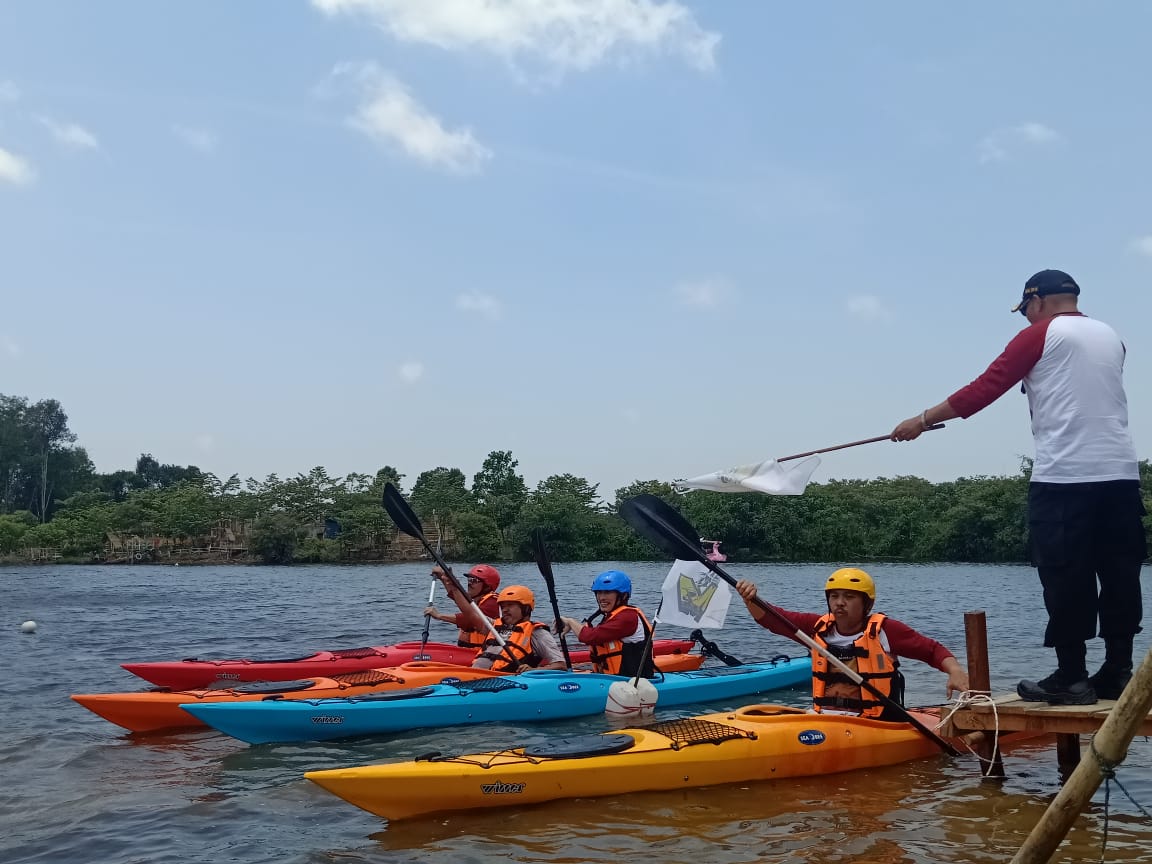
[304,705,940,819]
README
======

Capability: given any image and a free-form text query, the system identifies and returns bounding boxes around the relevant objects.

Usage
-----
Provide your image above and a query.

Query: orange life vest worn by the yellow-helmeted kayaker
[812,612,903,719]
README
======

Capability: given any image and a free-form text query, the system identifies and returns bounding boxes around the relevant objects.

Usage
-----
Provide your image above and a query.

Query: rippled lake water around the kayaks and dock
[0,563,1152,864]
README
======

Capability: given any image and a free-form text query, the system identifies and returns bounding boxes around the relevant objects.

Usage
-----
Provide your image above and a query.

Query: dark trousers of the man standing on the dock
[1028,480,1147,647]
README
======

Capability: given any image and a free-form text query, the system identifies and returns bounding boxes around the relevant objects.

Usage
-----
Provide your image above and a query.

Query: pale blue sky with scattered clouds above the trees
[0,0,1152,498]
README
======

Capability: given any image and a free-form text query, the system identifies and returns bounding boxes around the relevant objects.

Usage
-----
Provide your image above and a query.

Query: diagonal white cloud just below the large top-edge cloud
[333,63,492,174]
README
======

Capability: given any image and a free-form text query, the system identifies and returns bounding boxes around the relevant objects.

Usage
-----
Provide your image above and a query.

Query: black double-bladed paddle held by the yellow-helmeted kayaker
[620,494,960,756]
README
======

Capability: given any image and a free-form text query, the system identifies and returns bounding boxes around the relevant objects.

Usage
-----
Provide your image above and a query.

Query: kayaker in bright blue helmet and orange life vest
[560,570,655,679]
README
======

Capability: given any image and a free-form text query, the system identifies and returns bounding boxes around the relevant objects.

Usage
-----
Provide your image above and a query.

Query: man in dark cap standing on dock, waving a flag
[892,270,1147,705]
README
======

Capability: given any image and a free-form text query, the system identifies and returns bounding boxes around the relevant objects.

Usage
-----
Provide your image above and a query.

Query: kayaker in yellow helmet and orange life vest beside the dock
[736,567,969,720]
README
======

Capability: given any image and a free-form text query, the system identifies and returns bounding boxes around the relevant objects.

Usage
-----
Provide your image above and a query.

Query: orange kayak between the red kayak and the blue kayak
[71,653,704,732]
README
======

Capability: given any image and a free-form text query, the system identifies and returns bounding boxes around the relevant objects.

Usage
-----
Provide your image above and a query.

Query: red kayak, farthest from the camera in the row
[121,639,696,690]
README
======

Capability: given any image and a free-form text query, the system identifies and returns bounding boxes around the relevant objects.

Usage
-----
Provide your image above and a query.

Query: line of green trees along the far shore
[0,394,1152,563]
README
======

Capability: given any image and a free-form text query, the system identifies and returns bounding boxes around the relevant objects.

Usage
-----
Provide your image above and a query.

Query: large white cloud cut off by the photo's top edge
[312,0,720,70]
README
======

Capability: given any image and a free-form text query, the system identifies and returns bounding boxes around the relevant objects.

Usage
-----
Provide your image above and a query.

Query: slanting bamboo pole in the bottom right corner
[1011,649,1152,864]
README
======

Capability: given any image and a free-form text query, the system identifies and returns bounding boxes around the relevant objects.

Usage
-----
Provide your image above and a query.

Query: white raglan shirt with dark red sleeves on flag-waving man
[948,312,1139,483]
